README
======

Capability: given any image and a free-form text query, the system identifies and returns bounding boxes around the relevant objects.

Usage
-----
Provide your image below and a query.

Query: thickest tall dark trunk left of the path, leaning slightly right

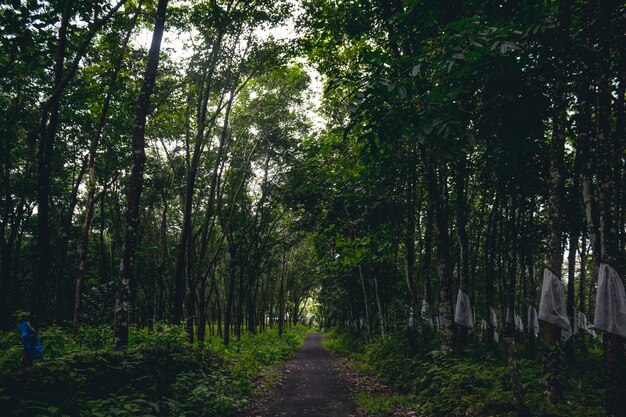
[113,0,168,349]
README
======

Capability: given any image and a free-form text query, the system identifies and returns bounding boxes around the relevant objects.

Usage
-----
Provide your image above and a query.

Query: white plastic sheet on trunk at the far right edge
[594,263,626,338]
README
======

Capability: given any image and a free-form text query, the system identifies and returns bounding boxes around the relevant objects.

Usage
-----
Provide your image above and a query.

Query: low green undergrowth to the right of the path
[325,330,604,417]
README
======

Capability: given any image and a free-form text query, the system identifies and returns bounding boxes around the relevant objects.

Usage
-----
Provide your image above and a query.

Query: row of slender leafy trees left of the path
[0,0,315,347]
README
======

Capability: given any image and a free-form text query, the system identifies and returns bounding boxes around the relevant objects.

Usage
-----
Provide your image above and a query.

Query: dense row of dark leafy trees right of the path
[289,0,626,415]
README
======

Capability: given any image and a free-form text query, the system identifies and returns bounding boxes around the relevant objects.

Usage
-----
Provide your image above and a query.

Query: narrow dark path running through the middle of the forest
[254,333,357,417]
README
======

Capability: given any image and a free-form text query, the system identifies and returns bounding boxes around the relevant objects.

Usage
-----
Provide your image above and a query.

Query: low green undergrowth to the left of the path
[0,325,307,417]
